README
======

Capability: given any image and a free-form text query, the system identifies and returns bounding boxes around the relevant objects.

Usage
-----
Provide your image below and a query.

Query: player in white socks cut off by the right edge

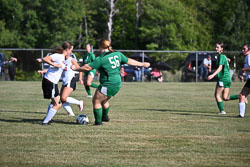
[239,44,250,118]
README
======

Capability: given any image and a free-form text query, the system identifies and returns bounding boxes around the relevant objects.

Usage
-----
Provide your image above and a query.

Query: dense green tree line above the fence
[0,0,250,51]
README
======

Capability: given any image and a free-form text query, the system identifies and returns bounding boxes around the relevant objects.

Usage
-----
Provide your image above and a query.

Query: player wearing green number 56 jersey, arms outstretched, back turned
[72,39,150,125]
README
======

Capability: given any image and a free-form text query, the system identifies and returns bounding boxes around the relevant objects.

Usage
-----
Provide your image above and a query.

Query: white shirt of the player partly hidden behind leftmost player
[62,57,76,85]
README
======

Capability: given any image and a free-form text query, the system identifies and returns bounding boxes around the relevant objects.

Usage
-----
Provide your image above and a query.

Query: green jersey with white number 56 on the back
[89,52,128,87]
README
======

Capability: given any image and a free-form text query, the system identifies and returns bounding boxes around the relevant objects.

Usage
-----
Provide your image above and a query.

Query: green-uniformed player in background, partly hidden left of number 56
[83,44,98,97]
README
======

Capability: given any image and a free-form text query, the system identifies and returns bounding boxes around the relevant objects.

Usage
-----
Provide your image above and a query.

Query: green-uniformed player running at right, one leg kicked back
[208,42,239,114]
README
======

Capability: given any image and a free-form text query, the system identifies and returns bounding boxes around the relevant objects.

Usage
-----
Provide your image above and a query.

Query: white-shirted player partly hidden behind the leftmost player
[61,49,83,116]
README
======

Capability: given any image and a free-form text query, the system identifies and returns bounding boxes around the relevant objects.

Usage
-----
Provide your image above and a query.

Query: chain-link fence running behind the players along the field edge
[0,48,244,82]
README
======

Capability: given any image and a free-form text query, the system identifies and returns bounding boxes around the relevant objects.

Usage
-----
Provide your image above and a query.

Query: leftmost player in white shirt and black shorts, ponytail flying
[42,41,73,125]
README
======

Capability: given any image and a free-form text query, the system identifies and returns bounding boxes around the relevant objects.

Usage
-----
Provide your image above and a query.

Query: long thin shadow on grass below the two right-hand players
[135,109,238,118]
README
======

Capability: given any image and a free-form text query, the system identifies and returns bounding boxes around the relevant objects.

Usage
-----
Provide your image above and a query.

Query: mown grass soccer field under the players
[0,81,250,167]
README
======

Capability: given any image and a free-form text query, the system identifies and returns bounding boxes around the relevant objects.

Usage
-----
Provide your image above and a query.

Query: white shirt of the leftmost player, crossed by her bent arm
[44,53,65,84]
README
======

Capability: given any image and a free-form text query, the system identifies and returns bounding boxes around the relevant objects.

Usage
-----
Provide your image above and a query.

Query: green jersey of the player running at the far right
[216,54,231,81]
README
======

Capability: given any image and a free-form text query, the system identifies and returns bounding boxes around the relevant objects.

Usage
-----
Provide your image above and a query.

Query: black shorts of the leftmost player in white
[42,78,59,99]
